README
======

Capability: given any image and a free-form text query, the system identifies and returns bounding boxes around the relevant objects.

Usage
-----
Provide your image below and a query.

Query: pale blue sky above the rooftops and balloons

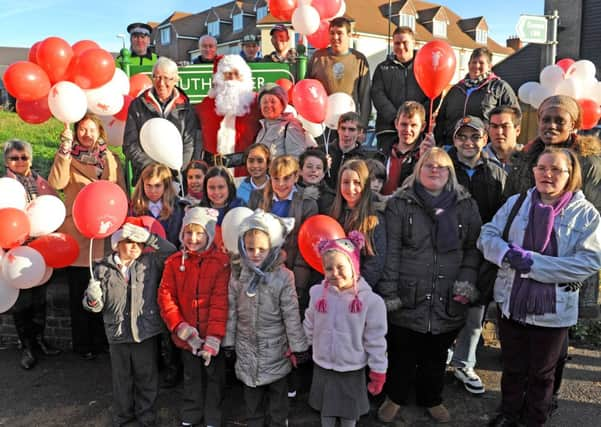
[0,0,544,51]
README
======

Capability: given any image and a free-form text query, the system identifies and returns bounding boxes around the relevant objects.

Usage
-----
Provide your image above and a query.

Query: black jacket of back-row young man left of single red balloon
[371,54,430,133]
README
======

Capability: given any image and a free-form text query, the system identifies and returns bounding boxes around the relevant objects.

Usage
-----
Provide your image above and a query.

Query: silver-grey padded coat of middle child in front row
[223,264,308,387]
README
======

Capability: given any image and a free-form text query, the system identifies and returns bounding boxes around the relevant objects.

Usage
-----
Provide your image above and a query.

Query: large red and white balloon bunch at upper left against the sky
[3,37,151,145]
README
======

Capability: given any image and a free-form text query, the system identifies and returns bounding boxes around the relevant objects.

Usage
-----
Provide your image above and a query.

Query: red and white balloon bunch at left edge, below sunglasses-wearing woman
[0,177,79,313]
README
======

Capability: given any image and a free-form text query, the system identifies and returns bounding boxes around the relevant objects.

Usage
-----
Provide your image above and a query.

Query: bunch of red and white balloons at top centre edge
[269,0,346,49]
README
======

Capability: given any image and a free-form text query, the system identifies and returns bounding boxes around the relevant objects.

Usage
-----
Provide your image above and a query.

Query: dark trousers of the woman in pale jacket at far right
[498,316,568,427]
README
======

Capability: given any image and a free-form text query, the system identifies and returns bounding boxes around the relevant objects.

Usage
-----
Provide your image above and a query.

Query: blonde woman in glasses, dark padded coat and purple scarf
[377,147,482,422]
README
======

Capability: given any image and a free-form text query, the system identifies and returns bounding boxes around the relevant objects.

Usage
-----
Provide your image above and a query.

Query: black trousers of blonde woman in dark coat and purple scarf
[384,324,459,408]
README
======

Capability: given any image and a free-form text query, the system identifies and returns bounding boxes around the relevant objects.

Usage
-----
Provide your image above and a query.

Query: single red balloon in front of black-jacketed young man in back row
[413,40,455,99]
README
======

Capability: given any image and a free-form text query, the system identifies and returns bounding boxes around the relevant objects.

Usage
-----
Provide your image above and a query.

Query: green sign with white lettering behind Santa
[129,62,294,104]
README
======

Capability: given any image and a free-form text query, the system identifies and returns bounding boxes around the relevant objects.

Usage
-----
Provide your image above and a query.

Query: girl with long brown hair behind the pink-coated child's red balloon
[330,159,386,288]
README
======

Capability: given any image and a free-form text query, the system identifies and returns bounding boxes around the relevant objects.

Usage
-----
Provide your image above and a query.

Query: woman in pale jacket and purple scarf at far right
[478,148,601,427]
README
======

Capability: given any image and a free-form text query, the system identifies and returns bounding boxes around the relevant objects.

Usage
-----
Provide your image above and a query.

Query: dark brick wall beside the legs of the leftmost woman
[0,270,71,349]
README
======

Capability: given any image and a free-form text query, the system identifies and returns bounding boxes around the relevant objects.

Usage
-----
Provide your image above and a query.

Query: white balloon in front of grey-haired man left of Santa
[140,117,184,170]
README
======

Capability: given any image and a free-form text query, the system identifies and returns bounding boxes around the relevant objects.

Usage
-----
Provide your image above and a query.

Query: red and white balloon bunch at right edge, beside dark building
[518,58,601,129]
